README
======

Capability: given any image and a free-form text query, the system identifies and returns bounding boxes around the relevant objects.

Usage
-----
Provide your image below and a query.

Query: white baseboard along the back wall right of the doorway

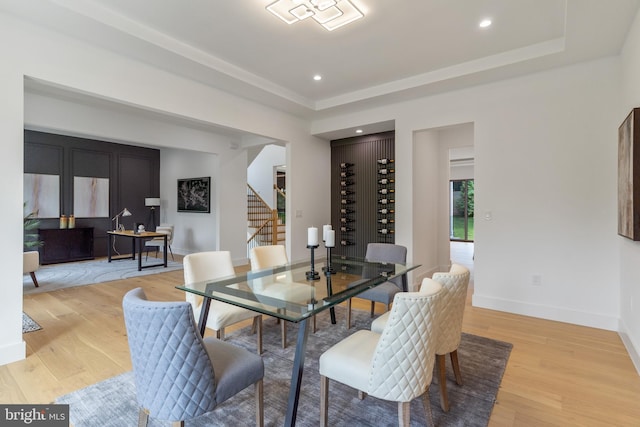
[472,294,620,332]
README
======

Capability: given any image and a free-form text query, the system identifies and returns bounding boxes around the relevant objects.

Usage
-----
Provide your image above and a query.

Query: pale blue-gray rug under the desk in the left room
[22,256,182,295]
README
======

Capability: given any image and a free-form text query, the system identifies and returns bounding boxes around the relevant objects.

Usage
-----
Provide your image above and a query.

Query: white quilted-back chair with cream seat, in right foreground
[319,286,441,426]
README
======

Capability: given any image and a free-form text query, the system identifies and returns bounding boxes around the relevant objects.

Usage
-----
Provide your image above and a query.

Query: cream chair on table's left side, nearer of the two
[182,251,262,354]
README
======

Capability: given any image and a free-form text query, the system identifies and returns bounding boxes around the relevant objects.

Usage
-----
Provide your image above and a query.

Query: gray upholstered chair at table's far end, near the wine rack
[347,243,407,329]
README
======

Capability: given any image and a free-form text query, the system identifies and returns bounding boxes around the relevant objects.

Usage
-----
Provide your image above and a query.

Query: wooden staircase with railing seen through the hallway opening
[247,184,286,253]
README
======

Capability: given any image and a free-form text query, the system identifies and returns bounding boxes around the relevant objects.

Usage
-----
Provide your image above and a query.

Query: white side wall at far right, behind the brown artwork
[617,7,640,372]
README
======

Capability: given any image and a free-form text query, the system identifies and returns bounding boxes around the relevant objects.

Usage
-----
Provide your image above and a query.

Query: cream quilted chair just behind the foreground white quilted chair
[371,264,470,411]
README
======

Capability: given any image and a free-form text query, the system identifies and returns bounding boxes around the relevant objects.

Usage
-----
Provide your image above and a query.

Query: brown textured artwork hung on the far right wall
[618,108,640,240]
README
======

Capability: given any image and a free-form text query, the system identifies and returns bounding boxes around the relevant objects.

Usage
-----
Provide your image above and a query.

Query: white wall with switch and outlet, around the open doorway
[312,58,620,330]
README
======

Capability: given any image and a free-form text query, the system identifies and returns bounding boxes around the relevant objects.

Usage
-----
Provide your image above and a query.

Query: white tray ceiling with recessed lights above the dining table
[0,0,639,128]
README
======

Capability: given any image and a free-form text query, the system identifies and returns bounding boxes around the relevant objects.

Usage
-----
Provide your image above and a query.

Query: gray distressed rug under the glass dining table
[55,307,512,427]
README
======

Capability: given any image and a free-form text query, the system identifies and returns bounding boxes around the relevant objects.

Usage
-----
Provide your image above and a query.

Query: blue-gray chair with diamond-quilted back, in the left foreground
[122,288,264,427]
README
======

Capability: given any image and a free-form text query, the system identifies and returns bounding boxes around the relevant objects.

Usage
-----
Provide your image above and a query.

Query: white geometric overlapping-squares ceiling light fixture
[266,0,364,31]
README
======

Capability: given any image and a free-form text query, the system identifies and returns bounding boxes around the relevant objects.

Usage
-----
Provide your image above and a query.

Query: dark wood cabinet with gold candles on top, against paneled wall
[38,227,94,264]
